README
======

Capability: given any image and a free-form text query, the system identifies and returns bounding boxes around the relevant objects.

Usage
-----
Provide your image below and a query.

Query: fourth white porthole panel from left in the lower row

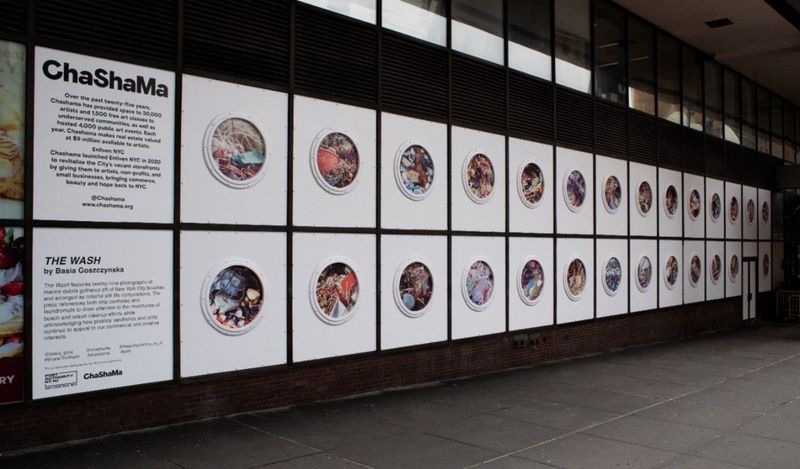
[450,236,506,339]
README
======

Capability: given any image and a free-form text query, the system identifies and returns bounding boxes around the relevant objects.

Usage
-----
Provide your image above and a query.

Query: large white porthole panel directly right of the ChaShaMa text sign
[181,75,288,225]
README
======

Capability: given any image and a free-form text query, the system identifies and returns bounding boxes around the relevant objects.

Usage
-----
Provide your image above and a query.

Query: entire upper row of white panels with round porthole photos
[181,76,772,240]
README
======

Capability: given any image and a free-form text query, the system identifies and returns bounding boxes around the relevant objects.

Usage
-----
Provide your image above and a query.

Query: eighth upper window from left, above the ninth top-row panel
[656,31,681,124]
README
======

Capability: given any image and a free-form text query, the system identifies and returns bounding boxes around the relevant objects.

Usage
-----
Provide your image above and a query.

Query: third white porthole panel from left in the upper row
[381,114,448,230]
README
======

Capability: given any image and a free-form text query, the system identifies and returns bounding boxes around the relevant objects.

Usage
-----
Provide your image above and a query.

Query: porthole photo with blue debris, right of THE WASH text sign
[201,261,265,335]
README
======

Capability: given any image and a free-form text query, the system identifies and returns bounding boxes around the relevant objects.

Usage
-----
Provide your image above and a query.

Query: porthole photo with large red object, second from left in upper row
[311,129,360,194]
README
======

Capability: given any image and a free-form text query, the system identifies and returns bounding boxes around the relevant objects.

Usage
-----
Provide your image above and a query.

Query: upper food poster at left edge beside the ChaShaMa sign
[0,41,25,220]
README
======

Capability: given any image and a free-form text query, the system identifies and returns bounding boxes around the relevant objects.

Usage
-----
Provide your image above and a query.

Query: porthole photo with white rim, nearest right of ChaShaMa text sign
[203,113,267,189]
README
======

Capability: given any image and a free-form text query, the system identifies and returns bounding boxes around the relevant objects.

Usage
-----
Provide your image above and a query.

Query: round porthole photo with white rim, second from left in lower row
[311,259,359,324]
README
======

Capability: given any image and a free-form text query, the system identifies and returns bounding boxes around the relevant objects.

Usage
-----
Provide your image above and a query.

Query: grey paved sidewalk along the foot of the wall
[0,324,800,469]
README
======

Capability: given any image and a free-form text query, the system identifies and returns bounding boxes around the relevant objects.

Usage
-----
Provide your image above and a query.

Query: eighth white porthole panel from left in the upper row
[628,162,660,236]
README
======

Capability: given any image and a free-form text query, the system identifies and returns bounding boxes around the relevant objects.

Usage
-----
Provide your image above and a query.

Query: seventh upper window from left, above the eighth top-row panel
[628,16,656,114]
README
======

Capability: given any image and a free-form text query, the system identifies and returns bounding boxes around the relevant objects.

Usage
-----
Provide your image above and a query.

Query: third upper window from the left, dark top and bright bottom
[450,0,504,65]
